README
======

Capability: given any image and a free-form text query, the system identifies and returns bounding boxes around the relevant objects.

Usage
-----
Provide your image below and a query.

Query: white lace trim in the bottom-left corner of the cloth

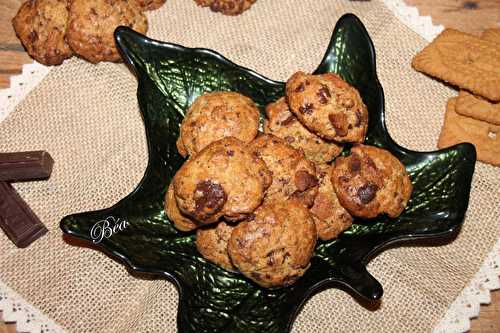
[0,281,65,333]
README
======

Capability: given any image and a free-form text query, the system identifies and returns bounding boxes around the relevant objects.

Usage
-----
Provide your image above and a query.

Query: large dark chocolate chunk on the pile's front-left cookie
[194,180,227,216]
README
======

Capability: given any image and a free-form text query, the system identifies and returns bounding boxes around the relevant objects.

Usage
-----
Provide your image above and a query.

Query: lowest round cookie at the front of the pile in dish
[228,199,317,288]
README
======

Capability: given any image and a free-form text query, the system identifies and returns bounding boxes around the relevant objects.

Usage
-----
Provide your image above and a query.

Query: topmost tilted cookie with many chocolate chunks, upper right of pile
[286,72,368,142]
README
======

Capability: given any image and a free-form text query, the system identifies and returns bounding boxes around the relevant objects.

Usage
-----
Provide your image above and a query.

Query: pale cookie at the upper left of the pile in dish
[177,91,259,157]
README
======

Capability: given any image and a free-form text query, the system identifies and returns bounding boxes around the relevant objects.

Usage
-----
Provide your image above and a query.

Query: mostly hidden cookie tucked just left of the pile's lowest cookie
[196,221,237,272]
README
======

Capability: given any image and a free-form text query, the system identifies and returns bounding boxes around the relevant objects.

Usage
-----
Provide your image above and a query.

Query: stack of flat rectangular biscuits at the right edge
[412,28,500,166]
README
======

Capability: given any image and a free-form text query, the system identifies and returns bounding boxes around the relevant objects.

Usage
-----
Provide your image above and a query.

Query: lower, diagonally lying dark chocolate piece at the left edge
[0,182,48,248]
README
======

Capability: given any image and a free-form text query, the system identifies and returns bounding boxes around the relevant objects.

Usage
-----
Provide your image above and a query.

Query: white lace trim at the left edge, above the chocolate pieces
[0,61,50,122]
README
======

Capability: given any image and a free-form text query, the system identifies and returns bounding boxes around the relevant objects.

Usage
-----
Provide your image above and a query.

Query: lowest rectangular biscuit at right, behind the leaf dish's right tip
[438,98,500,166]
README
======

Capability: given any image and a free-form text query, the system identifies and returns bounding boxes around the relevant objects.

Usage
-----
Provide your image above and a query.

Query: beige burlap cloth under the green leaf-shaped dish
[0,0,500,332]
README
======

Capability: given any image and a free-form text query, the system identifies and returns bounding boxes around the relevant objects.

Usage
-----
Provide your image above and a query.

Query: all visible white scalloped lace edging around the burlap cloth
[0,0,500,333]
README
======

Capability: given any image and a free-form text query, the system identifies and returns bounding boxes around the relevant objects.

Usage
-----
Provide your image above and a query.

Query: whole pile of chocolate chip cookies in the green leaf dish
[165,72,412,288]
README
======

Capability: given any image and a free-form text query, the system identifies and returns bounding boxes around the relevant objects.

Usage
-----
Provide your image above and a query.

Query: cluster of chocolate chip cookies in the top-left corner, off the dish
[12,0,166,65]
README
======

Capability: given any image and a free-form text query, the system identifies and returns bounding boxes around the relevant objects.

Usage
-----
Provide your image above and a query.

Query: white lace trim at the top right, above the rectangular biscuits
[383,0,444,42]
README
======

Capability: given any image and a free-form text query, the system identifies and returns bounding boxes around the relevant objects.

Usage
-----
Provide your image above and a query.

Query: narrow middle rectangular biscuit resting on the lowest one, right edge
[456,90,500,125]
